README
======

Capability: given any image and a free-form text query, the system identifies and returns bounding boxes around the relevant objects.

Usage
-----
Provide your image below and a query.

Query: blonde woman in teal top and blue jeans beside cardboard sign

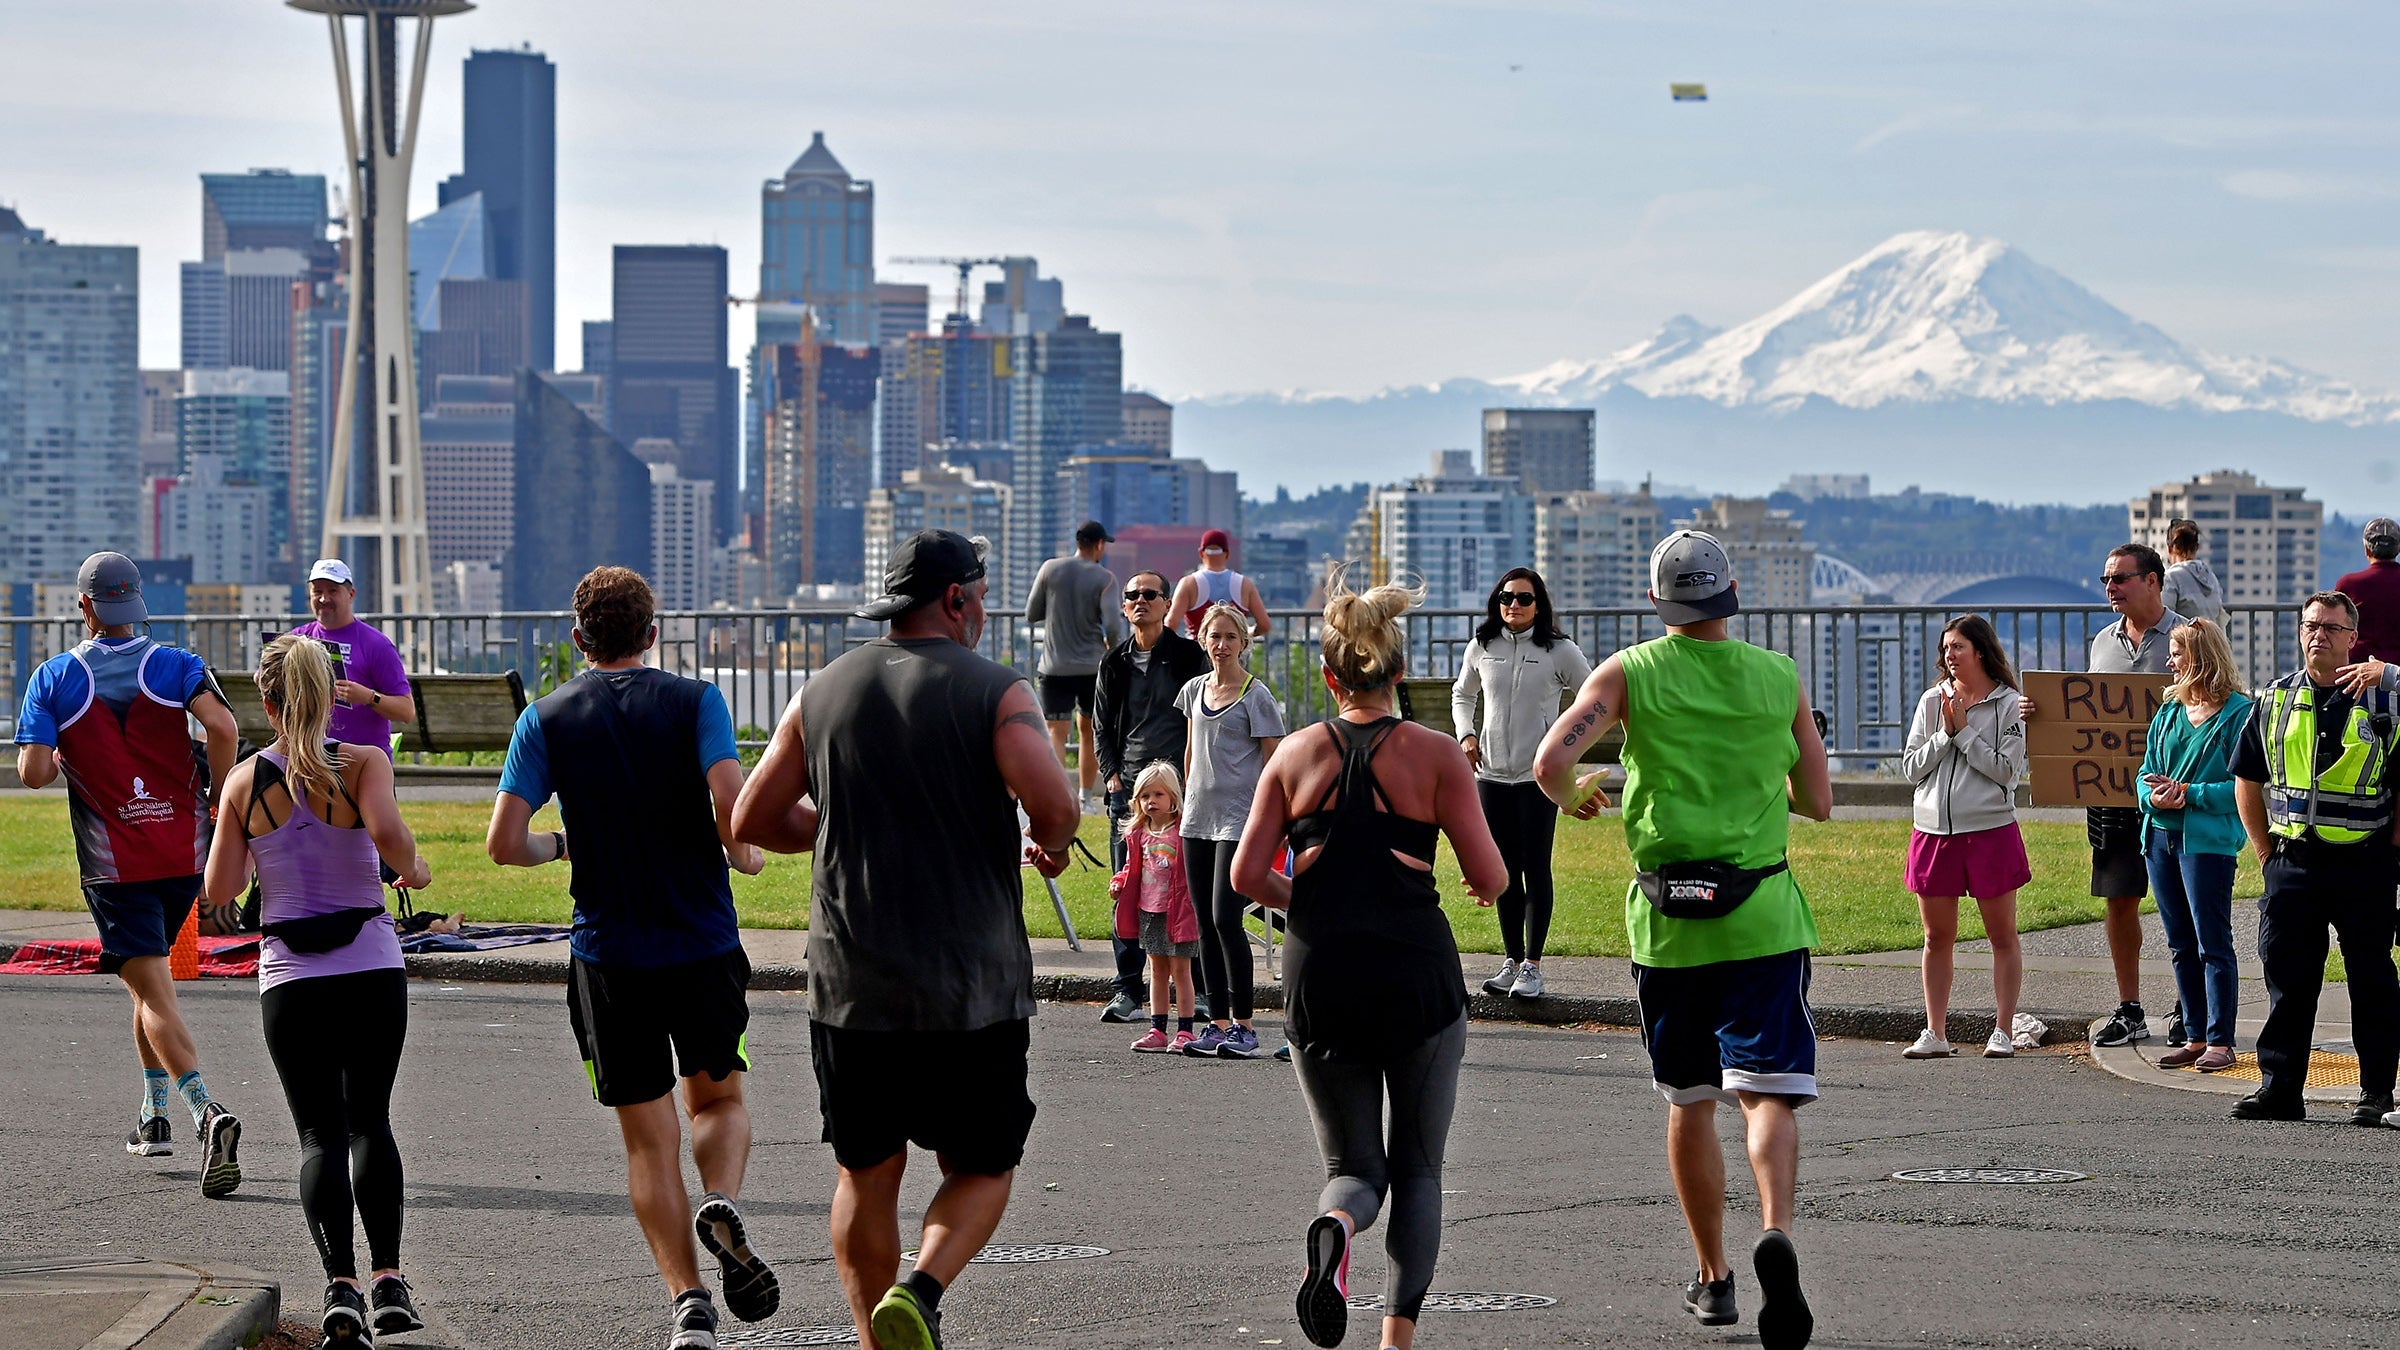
[2141,620,2251,1074]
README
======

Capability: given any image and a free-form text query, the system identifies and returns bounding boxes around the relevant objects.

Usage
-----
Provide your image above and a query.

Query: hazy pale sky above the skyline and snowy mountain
[0,0,2400,396]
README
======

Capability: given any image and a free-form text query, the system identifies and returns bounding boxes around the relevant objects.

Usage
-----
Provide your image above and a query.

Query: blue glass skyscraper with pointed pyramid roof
[758,132,883,346]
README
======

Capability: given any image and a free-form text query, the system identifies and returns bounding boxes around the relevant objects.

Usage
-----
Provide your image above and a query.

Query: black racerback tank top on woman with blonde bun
[1284,718,1466,1059]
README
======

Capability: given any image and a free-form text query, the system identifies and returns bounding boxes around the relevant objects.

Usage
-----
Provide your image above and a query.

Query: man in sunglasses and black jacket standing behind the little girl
[1092,572,1210,1021]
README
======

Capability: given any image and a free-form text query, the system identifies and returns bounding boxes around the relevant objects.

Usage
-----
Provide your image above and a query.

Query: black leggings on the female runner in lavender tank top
[259,970,408,1280]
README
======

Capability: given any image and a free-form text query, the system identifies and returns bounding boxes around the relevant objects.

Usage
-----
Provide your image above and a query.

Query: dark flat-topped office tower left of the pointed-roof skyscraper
[607,245,742,538]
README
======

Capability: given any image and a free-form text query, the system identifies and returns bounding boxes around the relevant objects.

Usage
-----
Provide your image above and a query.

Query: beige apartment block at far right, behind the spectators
[2126,468,2326,605]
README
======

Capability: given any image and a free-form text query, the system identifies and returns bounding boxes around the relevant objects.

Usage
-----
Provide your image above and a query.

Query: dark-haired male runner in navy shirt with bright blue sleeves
[485,567,780,1350]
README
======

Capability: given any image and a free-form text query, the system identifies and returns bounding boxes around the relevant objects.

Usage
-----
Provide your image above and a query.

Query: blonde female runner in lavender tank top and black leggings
[209,634,432,1345]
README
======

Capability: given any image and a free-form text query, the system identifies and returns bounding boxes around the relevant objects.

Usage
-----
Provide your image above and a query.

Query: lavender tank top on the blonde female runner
[250,749,403,992]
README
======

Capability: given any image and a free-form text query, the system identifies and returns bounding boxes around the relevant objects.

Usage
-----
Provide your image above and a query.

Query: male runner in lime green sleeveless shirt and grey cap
[1534,531,1834,1350]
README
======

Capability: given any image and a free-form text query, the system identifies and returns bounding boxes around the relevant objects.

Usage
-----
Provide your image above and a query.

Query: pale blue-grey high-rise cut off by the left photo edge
[0,207,142,584]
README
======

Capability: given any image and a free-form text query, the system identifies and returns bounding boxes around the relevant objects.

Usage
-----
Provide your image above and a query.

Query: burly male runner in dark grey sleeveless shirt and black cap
[734,531,1078,1350]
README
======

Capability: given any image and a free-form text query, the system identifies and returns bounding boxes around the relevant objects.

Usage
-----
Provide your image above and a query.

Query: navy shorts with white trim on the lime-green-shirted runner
[1634,951,1817,1107]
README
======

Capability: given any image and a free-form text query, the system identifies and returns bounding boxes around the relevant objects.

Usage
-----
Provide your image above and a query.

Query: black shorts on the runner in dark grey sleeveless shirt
[809,1019,1034,1177]
